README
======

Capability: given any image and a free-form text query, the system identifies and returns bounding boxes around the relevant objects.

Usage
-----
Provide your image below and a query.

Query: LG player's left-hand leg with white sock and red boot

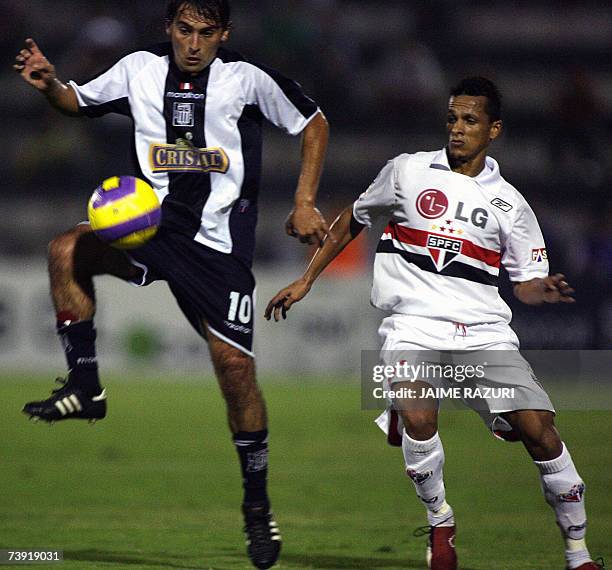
[393,381,457,570]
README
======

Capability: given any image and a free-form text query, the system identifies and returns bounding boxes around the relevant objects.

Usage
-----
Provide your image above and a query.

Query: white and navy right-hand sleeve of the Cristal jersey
[242,62,319,135]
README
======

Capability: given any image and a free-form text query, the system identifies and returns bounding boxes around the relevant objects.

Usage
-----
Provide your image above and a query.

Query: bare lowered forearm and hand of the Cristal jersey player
[285,112,329,245]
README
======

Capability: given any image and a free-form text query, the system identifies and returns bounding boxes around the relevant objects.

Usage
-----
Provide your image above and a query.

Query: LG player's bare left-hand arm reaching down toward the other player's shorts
[264,206,365,321]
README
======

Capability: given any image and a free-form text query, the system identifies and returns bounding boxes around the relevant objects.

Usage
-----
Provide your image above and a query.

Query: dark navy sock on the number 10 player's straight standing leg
[234,429,269,504]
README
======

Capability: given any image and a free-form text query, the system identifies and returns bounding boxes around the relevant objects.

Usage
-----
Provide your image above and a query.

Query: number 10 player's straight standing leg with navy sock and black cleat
[207,331,281,568]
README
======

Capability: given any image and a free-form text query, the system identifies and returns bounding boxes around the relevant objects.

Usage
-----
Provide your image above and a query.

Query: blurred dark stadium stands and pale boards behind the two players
[0,0,612,370]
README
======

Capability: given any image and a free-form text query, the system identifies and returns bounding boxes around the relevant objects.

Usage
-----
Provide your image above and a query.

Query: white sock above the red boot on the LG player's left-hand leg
[402,430,455,526]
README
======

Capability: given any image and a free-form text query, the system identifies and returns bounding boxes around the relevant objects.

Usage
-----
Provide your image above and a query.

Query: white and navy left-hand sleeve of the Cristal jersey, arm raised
[69,52,141,117]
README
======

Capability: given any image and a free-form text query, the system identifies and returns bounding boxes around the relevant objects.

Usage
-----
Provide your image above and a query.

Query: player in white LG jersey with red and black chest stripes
[265,77,599,570]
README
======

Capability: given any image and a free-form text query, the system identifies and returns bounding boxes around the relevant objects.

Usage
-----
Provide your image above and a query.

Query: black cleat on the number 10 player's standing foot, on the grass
[242,502,281,568]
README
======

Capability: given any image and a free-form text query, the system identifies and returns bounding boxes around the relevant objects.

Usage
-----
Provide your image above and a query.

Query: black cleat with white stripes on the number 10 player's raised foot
[23,378,106,423]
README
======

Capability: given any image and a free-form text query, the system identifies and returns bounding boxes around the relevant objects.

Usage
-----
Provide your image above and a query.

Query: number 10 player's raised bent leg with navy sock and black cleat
[23,224,141,422]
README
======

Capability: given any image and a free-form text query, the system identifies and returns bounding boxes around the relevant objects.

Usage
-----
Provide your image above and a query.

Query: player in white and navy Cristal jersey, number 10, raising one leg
[14,0,329,568]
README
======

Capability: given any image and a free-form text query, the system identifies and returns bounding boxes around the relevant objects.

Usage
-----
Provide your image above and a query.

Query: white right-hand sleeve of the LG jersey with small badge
[501,202,548,283]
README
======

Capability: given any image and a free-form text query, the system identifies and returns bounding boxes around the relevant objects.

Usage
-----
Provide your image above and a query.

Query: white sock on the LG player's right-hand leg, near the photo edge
[534,444,591,568]
